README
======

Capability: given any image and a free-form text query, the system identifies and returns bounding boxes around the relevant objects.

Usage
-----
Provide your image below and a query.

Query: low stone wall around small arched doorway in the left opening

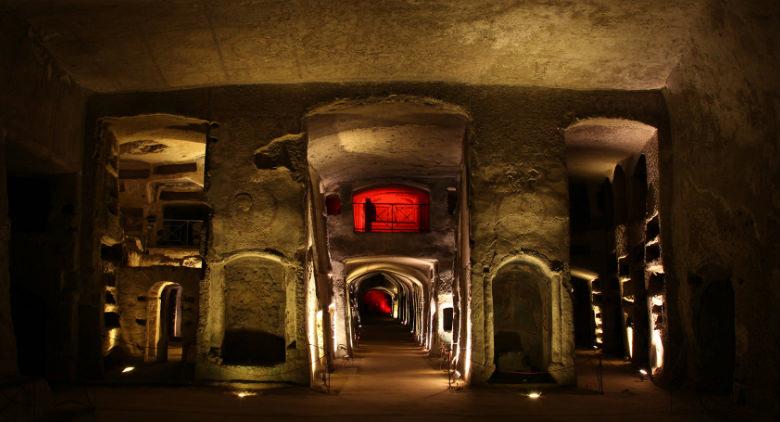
[116,266,203,363]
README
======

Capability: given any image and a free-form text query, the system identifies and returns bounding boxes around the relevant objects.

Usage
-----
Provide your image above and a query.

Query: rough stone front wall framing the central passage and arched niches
[88,83,665,382]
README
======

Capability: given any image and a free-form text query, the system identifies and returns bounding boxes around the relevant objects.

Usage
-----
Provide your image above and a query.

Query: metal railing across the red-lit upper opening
[352,202,430,233]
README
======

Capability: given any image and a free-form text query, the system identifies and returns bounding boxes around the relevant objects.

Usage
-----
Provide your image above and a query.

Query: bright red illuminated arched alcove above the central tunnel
[352,185,430,233]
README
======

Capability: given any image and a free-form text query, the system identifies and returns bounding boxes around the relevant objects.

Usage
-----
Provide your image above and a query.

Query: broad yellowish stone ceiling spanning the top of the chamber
[12,0,702,92]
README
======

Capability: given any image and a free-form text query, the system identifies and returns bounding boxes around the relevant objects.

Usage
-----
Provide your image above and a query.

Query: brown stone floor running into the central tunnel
[47,324,770,422]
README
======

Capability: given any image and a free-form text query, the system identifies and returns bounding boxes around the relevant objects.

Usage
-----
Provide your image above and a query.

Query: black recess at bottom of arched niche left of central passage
[222,330,285,365]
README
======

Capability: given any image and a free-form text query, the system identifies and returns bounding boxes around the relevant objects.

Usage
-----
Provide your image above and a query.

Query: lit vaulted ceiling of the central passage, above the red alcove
[306,96,467,189]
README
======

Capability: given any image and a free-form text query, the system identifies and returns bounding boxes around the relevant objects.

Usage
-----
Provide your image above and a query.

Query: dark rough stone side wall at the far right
[662,0,780,413]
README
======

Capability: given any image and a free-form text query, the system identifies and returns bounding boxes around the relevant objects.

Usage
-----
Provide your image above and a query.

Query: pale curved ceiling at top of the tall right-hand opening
[564,118,658,180]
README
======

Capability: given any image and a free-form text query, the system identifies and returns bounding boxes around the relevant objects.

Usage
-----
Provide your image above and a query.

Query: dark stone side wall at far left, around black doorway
[0,12,87,379]
